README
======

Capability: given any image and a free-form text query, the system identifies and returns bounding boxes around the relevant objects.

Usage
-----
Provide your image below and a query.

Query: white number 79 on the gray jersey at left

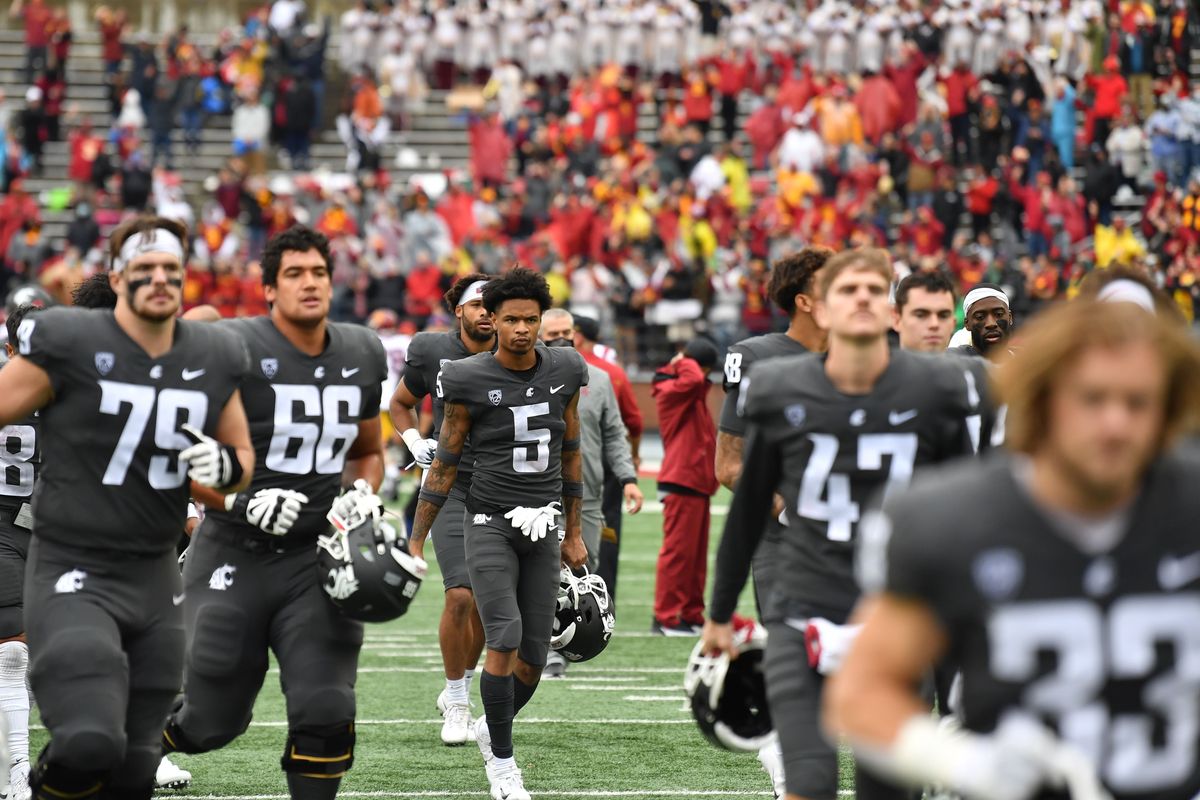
[100,380,209,489]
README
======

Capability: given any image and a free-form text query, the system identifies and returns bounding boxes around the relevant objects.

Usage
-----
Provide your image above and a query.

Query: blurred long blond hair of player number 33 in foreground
[992,300,1200,453]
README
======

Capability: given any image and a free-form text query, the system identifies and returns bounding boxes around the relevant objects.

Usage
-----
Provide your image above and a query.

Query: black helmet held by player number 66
[317,511,428,622]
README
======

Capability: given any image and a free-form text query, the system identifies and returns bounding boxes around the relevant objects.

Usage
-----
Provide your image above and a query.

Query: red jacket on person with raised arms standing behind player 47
[653,357,716,495]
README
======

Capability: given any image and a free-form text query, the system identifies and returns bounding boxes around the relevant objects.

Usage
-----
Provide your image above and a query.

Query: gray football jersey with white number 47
[714,350,978,622]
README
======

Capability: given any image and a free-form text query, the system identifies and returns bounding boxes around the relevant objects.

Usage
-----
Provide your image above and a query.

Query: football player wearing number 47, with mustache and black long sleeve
[702,249,977,800]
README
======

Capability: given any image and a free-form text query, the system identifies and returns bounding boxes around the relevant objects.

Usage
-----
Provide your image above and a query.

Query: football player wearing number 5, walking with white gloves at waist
[409,267,588,800]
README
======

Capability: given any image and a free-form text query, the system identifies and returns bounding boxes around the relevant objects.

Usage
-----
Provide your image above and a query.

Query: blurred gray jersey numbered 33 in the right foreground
[873,455,1200,800]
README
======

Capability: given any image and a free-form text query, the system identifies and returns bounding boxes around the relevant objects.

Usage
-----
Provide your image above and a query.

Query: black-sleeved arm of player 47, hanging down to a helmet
[702,417,780,657]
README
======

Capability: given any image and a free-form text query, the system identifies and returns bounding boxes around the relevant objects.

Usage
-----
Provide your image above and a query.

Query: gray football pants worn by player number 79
[25,537,184,796]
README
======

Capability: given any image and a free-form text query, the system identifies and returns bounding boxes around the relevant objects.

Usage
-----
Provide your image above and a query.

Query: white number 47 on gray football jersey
[797,433,917,542]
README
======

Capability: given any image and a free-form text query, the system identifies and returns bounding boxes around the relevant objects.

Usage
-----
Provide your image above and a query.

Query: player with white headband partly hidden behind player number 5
[389,272,496,745]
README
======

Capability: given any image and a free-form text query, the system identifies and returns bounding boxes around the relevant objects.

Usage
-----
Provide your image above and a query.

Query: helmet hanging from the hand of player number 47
[683,618,774,752]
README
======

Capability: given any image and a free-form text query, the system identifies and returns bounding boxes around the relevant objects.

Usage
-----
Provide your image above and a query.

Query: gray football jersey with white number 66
[209,317,388,541]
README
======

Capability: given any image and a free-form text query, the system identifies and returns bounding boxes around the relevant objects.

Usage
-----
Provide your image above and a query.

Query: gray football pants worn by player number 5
[466,509,562,667]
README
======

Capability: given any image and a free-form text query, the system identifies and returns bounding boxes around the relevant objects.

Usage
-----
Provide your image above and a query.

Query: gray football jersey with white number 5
[436,344,588,513]
